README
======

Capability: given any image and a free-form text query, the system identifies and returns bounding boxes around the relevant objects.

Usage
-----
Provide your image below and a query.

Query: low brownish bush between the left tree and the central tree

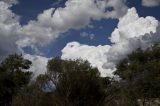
[12,83,47,106]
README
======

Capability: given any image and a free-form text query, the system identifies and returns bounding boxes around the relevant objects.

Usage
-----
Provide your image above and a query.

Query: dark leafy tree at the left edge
[0,54,31,106]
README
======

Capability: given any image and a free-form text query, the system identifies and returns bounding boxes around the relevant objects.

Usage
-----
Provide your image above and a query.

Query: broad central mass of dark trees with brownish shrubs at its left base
[13,58,112,106]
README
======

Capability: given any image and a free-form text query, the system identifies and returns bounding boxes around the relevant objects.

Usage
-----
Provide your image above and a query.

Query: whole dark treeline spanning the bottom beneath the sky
[0,45,160,106]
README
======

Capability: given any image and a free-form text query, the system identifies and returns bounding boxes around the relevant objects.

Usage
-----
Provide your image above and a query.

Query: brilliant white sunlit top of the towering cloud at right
[110,8,158,43]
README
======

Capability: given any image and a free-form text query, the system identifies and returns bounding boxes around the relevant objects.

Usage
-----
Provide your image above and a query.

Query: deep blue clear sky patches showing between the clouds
[8,0,160,57]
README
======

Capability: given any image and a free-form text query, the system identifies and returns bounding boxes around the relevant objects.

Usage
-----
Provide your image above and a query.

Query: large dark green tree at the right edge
[115,45,160,106]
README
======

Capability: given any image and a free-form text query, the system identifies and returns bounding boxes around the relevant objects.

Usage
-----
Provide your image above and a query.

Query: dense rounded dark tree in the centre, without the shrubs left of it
[48,59,109,106]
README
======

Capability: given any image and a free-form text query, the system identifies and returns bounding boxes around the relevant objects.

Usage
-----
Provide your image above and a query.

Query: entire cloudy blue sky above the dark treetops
[0,0,160,76]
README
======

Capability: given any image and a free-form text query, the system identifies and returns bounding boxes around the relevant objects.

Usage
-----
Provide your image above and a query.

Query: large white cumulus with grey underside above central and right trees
[62,8,160,76]
